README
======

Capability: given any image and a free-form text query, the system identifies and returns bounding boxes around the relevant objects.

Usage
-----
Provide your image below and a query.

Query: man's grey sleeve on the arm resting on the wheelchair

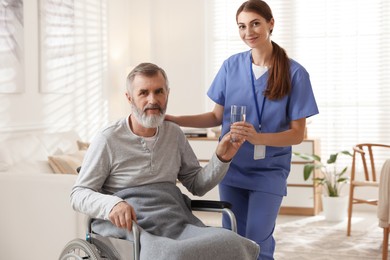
[71,134,122,219]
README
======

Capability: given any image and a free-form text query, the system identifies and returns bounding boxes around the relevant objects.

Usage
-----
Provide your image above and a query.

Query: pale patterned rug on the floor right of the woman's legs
[274,210,390,260]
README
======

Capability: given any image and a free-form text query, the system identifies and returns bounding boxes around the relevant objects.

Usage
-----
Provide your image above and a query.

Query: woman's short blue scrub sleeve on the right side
[288,67,319,120]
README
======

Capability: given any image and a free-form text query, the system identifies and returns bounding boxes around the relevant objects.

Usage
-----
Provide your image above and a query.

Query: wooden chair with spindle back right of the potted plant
[347,143,390,259]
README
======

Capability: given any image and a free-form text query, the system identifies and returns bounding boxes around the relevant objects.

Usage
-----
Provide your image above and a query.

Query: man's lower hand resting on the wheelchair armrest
[108,201,137,232]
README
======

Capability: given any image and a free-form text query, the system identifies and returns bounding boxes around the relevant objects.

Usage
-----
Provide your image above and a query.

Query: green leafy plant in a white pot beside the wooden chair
[294,151,352,221]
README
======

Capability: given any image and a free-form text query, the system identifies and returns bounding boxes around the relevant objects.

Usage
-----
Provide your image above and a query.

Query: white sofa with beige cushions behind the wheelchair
[0,131,86,260]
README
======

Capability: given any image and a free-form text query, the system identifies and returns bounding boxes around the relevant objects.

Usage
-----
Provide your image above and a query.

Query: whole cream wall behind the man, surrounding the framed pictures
[0,0,206,139]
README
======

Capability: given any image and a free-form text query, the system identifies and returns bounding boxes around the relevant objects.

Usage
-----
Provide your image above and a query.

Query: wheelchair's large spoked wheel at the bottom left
[59,238,101,260]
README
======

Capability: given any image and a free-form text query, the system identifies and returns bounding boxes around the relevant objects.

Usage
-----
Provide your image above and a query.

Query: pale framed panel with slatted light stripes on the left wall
[40,0,107,93]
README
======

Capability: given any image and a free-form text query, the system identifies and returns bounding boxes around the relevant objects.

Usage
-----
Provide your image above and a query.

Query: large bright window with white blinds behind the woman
[206,0,390,166]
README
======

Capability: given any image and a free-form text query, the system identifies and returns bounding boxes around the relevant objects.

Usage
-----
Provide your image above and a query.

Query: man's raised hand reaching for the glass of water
[216,132,245,162]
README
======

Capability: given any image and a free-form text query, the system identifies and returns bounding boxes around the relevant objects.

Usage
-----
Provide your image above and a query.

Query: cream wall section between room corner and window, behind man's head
[114,0,206,118]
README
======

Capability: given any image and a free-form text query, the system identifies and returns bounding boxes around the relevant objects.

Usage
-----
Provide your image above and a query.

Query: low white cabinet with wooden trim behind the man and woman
[184,137,322,216]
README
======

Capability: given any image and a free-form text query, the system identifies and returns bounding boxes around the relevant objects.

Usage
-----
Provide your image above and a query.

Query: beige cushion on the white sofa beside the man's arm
[48,150,85,174]
